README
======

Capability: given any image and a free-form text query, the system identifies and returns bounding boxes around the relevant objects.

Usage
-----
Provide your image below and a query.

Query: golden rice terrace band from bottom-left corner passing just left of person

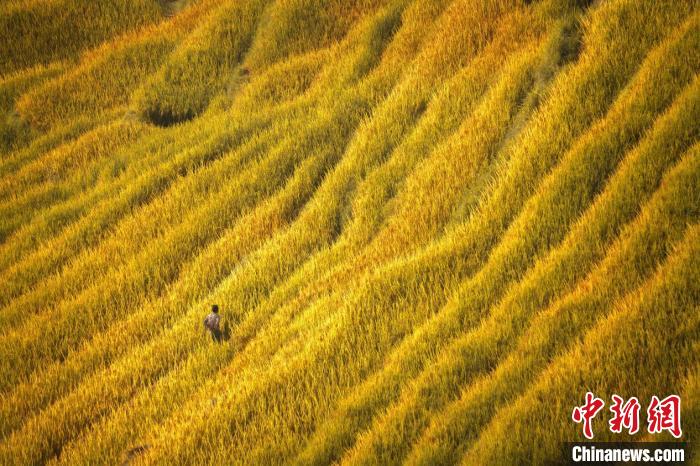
[0,137,350,463]
